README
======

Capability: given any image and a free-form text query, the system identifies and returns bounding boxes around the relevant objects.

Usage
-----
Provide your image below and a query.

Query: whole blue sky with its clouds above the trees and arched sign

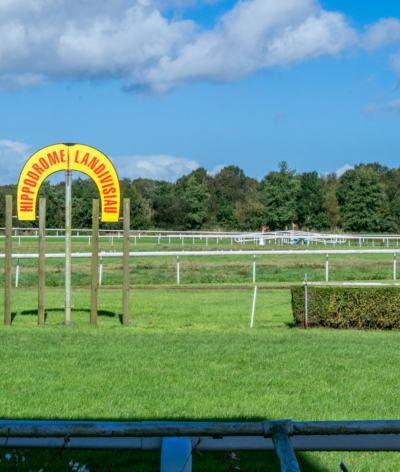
[0,0,400,184]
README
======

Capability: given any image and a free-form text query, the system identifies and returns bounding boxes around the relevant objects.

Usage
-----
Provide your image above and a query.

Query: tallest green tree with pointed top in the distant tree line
[261,161,300,231]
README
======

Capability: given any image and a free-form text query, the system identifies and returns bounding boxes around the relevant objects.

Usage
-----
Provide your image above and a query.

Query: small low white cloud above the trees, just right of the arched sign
[113,154,199,182]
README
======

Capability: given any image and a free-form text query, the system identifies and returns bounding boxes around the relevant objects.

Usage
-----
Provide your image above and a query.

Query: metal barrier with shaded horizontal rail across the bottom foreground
[0,420,400,472]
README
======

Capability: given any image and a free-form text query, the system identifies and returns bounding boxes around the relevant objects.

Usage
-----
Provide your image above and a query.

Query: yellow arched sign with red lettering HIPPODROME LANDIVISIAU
[17,144,121,222]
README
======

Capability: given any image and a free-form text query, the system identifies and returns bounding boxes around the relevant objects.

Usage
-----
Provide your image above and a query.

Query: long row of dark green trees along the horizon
[0,161,400,233]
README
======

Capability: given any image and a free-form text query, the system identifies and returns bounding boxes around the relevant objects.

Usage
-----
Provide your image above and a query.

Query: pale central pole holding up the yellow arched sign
[64,155,72,325]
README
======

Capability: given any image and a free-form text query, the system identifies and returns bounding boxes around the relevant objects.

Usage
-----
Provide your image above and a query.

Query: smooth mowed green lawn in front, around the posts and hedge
[0,289,400,472]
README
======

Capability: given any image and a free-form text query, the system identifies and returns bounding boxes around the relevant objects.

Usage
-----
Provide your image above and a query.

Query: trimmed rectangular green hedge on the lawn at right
[292,286,400,329]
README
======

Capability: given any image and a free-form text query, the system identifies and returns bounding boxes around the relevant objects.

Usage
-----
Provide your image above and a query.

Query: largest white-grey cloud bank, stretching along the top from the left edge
[0,0,358,93]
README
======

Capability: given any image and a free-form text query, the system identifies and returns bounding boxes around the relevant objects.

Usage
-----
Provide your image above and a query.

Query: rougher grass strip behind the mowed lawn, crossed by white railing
[0,237,400,288]
